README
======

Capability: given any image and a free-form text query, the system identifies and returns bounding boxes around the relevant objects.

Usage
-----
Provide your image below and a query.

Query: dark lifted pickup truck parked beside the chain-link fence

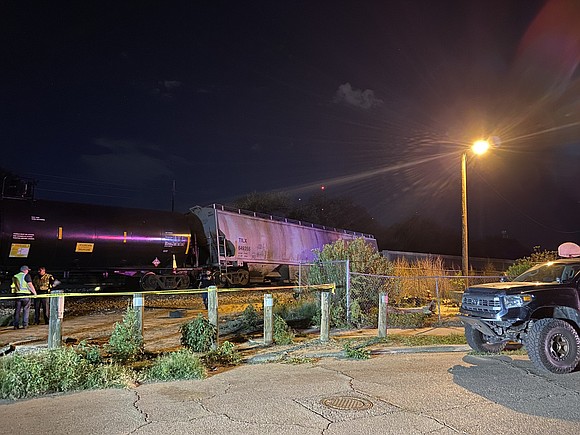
[459,242,580,373]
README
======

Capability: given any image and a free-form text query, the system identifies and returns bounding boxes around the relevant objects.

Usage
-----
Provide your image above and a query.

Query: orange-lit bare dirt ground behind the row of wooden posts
[0,291,457,355]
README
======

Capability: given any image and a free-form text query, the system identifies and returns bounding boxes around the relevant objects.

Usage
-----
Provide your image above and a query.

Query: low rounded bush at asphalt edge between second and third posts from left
[145,349,206,381]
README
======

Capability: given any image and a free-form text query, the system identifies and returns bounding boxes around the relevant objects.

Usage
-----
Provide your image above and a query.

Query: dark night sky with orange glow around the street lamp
[0,0,580,254]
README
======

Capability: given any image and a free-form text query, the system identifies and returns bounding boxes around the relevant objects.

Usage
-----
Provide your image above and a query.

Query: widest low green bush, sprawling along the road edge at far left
[0,347,135,399]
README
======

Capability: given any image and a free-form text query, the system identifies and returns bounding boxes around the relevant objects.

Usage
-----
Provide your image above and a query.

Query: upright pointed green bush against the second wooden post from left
[105,307,144,363]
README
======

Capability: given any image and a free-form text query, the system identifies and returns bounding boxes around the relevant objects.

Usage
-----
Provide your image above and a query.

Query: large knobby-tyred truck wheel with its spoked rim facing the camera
[526,319,580,373]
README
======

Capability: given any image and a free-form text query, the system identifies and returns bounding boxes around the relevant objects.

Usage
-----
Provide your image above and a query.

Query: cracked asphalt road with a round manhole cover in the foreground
[0,352,580,435]
